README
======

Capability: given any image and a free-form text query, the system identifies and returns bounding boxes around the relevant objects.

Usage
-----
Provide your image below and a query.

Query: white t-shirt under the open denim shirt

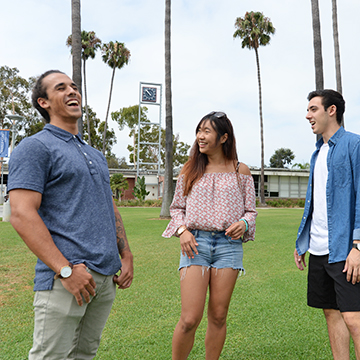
[309,143,329,255]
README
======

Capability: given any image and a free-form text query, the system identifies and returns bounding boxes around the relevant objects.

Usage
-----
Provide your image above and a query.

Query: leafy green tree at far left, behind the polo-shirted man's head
[0,65,44,145]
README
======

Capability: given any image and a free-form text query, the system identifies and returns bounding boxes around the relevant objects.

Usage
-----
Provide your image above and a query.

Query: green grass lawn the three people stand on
[0,208,355,360]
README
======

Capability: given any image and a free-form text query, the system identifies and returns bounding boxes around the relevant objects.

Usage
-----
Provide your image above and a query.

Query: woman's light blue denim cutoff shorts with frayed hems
[179,230,244,271]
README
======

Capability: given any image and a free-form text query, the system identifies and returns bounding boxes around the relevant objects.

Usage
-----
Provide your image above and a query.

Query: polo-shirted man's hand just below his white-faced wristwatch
[60,264,96,306]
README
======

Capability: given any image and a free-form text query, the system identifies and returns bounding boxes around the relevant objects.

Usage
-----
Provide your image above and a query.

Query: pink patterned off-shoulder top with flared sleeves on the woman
[162,172,257,242]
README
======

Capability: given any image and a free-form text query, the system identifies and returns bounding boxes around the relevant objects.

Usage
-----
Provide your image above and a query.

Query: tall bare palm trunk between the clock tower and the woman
[160,0,173,217]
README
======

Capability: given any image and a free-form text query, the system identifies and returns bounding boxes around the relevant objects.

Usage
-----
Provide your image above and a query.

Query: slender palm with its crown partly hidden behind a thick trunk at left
[66,30,101,146]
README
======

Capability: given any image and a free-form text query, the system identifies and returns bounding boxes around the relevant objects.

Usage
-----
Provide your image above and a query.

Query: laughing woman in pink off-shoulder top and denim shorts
[163,112,257,360]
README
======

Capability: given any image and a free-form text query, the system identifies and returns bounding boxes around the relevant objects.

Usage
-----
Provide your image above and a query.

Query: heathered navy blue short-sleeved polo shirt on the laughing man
[8,124,121,291]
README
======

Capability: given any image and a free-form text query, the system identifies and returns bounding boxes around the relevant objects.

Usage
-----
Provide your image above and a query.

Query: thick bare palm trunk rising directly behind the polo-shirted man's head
[71,0,83,136]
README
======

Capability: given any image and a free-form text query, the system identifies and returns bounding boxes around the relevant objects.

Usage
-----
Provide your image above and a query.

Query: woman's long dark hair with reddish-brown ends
[181,111,238,196]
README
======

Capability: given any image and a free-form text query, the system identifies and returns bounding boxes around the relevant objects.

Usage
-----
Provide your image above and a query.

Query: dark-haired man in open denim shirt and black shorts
[294,90,360,359]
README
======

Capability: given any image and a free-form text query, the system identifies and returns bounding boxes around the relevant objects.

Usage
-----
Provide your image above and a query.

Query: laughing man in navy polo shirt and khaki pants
[8,70,133,360]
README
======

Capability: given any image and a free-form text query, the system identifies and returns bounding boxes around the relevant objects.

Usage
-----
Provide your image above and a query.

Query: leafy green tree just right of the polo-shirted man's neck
[83,106,116,158]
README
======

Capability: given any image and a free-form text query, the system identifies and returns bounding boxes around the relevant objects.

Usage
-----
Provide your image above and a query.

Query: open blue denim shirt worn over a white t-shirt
[296,127,360,263]
